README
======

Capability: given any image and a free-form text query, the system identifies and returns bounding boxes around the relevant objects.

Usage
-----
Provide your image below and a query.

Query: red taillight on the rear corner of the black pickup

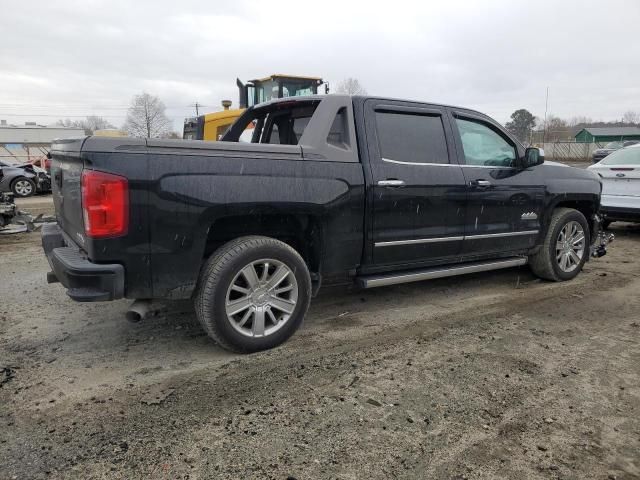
[82,170,129,238]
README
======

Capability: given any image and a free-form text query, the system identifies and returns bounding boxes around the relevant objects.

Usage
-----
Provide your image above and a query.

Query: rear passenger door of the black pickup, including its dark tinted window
[366,100,466,266]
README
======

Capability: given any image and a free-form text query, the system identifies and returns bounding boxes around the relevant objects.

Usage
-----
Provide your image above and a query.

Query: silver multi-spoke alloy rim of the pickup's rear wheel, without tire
[225,258,298,337]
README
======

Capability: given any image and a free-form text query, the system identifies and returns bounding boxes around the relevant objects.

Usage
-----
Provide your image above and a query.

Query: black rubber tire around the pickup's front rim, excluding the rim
[529,208,591,282]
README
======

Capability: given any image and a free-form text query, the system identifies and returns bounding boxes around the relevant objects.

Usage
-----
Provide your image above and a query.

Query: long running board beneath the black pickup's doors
[356,257,527,288]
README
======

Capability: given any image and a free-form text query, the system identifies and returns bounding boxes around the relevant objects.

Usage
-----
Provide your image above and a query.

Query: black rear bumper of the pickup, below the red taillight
[42,223,124,302]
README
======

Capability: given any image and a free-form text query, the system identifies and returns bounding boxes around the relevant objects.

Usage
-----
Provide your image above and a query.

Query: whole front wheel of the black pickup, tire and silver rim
[529,208,590,282]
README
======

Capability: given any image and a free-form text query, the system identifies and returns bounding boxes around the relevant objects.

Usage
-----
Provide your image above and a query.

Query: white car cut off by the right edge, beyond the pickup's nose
[589,144,640,228]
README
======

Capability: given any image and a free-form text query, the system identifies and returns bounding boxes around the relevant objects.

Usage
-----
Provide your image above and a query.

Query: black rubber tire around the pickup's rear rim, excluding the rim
[194,236,311,353]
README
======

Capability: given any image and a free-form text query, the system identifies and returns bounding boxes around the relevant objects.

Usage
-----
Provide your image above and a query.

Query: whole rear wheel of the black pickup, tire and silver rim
[195,236,311,353]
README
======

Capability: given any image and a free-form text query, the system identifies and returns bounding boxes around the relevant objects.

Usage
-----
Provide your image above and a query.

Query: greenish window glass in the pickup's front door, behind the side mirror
[456,118,516,167]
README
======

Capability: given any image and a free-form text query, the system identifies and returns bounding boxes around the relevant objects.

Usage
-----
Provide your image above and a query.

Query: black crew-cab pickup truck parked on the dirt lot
[42,95,605,352]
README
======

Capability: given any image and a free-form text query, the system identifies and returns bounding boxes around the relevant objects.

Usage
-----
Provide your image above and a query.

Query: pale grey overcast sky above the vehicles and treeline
[0,0,640,132]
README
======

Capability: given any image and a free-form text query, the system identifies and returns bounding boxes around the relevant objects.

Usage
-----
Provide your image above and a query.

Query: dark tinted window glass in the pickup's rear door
[376,112,449,163]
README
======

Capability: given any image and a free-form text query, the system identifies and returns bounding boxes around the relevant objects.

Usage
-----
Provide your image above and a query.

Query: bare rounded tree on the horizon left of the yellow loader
[123,92,171,138]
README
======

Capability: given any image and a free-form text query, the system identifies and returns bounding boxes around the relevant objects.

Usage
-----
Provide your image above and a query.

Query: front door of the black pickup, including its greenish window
[452,112,545,255]
